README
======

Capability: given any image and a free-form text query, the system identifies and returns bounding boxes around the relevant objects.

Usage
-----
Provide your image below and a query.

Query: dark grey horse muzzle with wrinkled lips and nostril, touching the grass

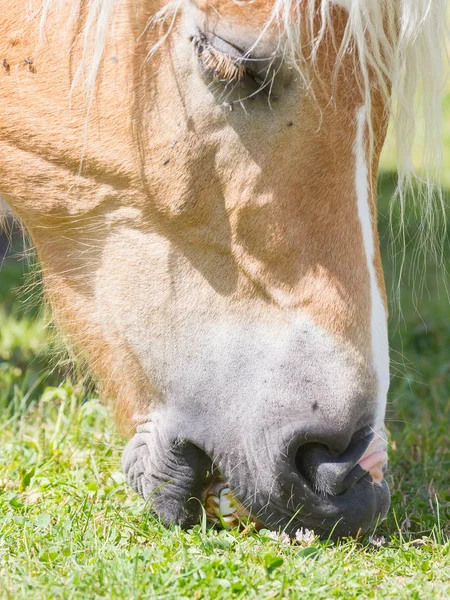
[123,423,389,538]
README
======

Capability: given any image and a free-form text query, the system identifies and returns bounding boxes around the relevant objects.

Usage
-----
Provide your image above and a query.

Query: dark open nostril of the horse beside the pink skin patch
[295,435,372,496]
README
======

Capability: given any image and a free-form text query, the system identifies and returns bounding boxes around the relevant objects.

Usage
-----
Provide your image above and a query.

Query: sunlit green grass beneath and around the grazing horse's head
[0,176,450,600]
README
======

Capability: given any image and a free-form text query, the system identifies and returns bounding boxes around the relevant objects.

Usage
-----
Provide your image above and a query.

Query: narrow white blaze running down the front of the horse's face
[354,107,389,429]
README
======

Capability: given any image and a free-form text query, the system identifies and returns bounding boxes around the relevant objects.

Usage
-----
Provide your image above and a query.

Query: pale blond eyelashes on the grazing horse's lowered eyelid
[190,35,249,83]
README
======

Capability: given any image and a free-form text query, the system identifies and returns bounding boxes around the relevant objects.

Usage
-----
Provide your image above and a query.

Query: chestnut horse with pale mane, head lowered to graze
[0,0,447,536]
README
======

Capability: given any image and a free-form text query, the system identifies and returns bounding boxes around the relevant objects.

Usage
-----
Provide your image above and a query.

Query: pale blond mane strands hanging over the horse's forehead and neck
[40,0,448,255]
